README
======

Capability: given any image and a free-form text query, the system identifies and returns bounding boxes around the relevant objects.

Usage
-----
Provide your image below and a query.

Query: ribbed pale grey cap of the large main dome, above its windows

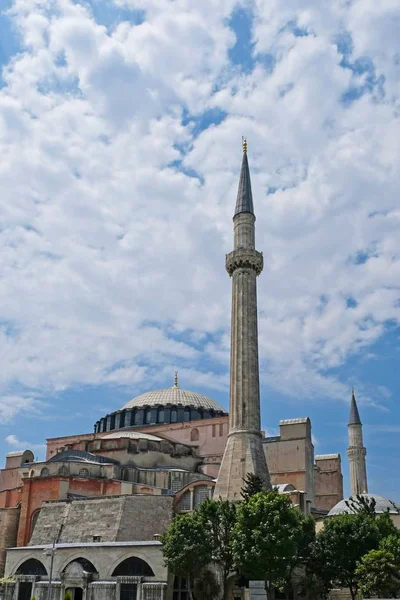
[123,386,226,413]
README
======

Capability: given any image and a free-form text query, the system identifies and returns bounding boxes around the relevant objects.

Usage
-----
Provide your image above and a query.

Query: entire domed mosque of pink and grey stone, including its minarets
[0,143,400,600]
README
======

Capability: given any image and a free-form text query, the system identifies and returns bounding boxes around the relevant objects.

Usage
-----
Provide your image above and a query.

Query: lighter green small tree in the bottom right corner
[356,550,400,598]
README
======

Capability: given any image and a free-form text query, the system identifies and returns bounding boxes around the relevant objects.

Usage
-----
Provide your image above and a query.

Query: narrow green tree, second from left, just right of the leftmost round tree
[197,500,236,600]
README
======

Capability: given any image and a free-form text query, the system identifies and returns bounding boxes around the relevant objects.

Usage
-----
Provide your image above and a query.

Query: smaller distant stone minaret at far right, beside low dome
[347,390,368,496]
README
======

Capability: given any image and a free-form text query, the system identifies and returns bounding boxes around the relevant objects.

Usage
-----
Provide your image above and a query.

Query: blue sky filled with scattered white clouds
[0,0,400,501]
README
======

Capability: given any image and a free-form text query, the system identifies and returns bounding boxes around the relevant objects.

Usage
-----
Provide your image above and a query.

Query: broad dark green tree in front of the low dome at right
[314,511,381,600]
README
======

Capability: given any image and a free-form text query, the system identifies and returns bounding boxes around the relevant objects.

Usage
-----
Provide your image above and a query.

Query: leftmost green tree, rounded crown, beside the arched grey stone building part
[161,511,213,600]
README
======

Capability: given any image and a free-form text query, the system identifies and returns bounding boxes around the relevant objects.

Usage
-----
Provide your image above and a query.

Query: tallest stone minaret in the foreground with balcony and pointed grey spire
[214,140,270,500]
